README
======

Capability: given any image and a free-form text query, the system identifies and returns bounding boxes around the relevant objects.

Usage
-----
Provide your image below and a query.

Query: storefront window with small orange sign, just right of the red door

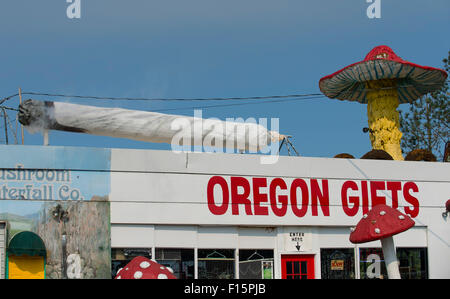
[320,248,355,279]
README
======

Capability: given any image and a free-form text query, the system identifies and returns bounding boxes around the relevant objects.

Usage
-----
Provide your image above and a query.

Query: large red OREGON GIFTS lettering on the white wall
[206,176,419,218]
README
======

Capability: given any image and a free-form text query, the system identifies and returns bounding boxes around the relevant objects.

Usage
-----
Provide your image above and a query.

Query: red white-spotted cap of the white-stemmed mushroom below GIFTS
[350,204,415,243]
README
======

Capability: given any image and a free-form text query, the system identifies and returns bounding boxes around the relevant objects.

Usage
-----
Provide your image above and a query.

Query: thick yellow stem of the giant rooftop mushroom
[366,79,404,160]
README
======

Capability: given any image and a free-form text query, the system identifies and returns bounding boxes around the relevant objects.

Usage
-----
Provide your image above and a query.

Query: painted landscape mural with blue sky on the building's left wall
[0,146,111,278]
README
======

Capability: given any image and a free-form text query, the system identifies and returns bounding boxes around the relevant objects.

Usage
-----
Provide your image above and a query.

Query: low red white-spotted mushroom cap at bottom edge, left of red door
[115,256,177,279]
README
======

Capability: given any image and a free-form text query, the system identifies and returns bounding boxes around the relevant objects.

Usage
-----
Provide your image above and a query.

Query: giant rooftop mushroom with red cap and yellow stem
[319,46,447,160]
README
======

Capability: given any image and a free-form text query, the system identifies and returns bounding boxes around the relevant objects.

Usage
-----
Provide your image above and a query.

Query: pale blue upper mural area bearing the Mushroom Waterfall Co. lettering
[0,145,109,201]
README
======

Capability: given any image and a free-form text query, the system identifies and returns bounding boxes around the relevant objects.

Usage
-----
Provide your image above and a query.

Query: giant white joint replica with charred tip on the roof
[19,100,285,152]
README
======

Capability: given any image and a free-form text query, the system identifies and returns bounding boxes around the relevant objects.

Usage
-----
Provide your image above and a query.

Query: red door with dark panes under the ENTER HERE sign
[281,254,314,279]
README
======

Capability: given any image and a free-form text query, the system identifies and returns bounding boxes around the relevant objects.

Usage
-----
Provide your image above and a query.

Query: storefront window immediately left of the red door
[239,249,274,279]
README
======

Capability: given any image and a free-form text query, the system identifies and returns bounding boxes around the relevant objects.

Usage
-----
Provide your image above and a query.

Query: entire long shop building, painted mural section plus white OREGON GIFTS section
[0,145,450,279]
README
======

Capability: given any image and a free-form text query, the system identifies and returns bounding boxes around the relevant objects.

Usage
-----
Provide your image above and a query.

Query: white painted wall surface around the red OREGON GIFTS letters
[110,149,450,278]
